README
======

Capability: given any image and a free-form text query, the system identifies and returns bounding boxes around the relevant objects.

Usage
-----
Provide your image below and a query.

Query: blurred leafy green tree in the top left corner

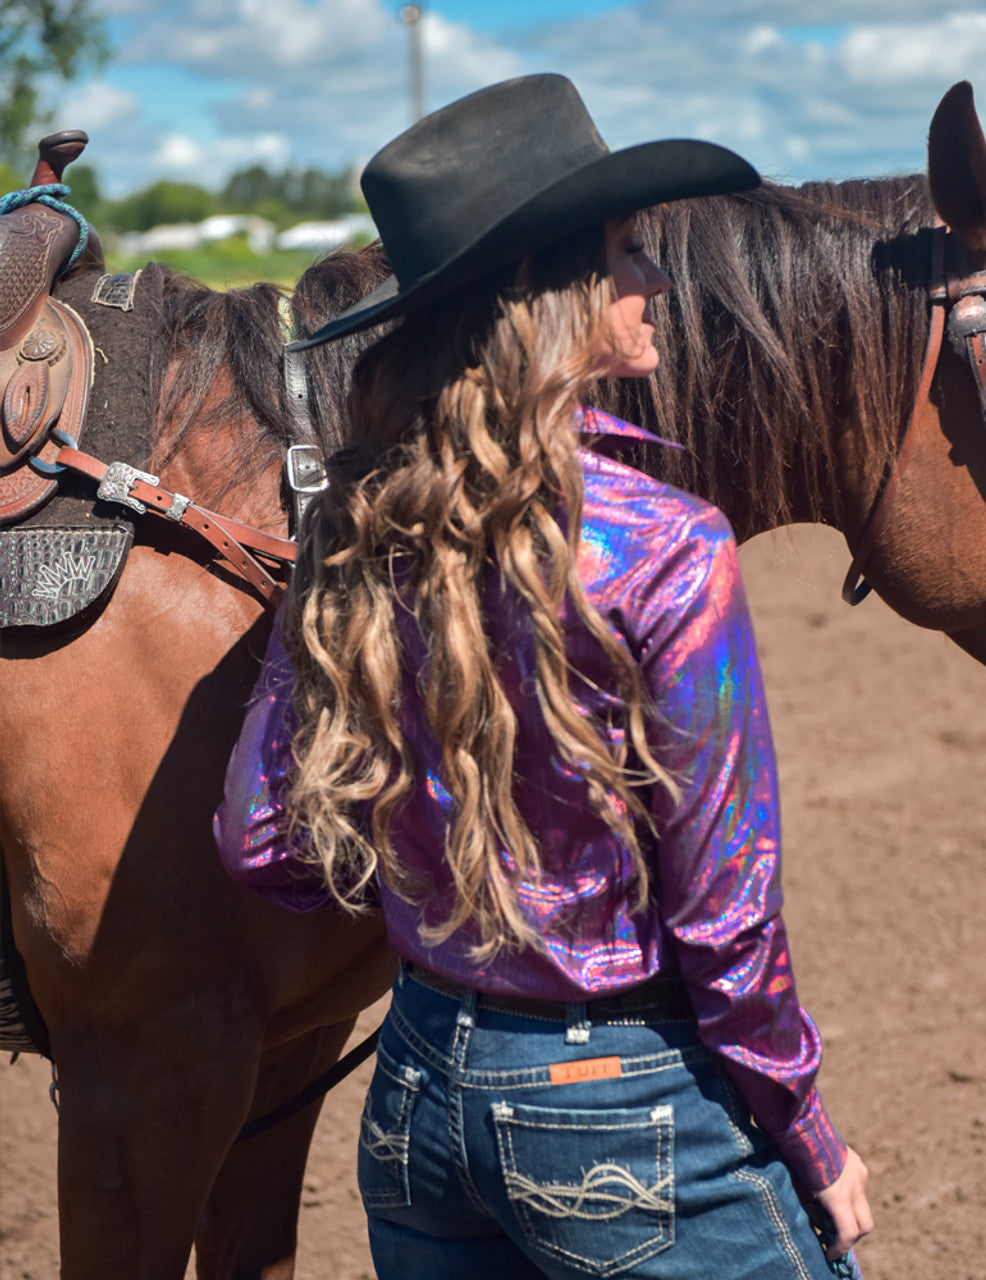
[0,0,109,171]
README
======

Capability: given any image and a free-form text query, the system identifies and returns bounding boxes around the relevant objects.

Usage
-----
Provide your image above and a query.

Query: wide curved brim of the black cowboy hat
[287,138,761,351]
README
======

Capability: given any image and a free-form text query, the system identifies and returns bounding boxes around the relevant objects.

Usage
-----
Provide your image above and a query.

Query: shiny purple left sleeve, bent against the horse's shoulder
[213,617,330,911]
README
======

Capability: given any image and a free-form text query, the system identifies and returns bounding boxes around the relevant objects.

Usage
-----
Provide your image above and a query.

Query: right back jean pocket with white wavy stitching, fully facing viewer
[493,1102,675,1276]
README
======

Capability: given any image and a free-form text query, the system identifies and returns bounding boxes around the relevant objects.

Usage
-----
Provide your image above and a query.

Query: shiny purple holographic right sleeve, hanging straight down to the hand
[624,496,845,1190]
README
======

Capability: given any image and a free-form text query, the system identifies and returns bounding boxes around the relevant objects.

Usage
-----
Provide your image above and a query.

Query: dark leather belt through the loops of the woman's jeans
[402,961,695,1023]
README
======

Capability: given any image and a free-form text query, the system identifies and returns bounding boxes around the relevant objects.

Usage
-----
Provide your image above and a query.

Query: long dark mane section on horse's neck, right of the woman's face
[599,177,933,538]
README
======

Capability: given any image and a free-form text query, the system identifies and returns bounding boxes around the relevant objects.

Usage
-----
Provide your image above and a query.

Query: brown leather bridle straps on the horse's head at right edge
[843,221,986,604]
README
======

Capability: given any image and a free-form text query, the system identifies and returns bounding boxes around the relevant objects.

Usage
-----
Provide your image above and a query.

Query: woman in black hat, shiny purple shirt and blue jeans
[216,76,871,1280]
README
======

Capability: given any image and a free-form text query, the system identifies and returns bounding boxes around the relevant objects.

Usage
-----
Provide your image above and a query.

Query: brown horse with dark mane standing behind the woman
[0,87,986,1280]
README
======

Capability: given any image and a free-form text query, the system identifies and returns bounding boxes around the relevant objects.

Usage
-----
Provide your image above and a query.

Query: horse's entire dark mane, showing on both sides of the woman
[149,177,933,538]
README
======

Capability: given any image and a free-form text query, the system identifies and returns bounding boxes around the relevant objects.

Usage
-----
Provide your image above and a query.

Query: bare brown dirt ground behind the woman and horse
[0,530,986,1280]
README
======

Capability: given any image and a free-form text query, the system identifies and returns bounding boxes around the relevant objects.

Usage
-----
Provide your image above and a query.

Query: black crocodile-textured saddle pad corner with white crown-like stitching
[0,522,133,627]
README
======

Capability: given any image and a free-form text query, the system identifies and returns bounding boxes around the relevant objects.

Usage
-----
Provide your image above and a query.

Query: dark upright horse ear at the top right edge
[928,81,986,250]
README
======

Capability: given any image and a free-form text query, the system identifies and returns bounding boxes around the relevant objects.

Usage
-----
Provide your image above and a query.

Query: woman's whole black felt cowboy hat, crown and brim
[287,76,759,351]
